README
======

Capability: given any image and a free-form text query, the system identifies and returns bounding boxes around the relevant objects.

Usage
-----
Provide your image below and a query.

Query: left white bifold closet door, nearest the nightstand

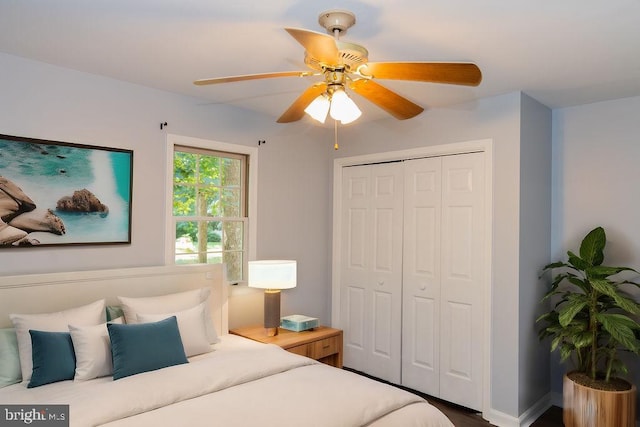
[340,163,403,383]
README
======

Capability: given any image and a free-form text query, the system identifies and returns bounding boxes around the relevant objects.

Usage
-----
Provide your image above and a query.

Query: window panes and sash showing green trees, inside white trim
[170,137,258,283]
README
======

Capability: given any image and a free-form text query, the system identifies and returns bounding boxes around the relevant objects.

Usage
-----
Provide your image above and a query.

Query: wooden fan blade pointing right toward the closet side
[358,62,482,86]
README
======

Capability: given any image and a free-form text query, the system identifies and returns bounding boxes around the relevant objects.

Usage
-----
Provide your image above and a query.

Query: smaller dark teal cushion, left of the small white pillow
[27,329,76,388]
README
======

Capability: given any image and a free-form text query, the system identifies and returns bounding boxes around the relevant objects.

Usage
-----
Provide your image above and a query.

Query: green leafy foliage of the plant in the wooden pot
[536,227,640,382]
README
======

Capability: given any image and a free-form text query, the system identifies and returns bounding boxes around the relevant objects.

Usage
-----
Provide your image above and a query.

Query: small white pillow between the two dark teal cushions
[69,317,124,381]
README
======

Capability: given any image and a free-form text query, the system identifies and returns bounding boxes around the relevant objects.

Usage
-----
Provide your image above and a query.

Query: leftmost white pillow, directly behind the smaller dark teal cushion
[9,300,106,382]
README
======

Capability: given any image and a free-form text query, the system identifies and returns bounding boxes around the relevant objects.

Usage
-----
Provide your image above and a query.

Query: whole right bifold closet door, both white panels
[402,153,486,410]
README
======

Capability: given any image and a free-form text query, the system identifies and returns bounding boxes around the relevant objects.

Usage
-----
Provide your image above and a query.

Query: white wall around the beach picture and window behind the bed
[0,54,333,327]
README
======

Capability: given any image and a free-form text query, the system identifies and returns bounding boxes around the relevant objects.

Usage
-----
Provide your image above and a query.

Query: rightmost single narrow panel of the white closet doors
[439,153,485,410]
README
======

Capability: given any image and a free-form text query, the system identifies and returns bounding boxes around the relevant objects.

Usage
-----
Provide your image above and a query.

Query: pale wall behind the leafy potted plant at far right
[551,97,640,406]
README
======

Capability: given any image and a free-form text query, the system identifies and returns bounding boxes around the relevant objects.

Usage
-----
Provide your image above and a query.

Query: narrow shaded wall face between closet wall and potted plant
[518,95,552,414]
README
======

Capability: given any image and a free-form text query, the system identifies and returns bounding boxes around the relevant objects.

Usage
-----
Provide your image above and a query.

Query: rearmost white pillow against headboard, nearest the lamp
[118,288,218,344]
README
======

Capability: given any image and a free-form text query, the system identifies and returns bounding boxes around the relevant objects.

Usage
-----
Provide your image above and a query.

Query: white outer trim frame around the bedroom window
[165,134,258,284]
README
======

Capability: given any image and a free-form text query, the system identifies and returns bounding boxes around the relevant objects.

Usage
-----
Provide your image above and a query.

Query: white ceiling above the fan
[0,0,640,120]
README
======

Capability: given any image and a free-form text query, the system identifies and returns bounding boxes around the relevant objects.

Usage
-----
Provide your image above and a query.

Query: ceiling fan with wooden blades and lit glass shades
[194,10,482,124]
